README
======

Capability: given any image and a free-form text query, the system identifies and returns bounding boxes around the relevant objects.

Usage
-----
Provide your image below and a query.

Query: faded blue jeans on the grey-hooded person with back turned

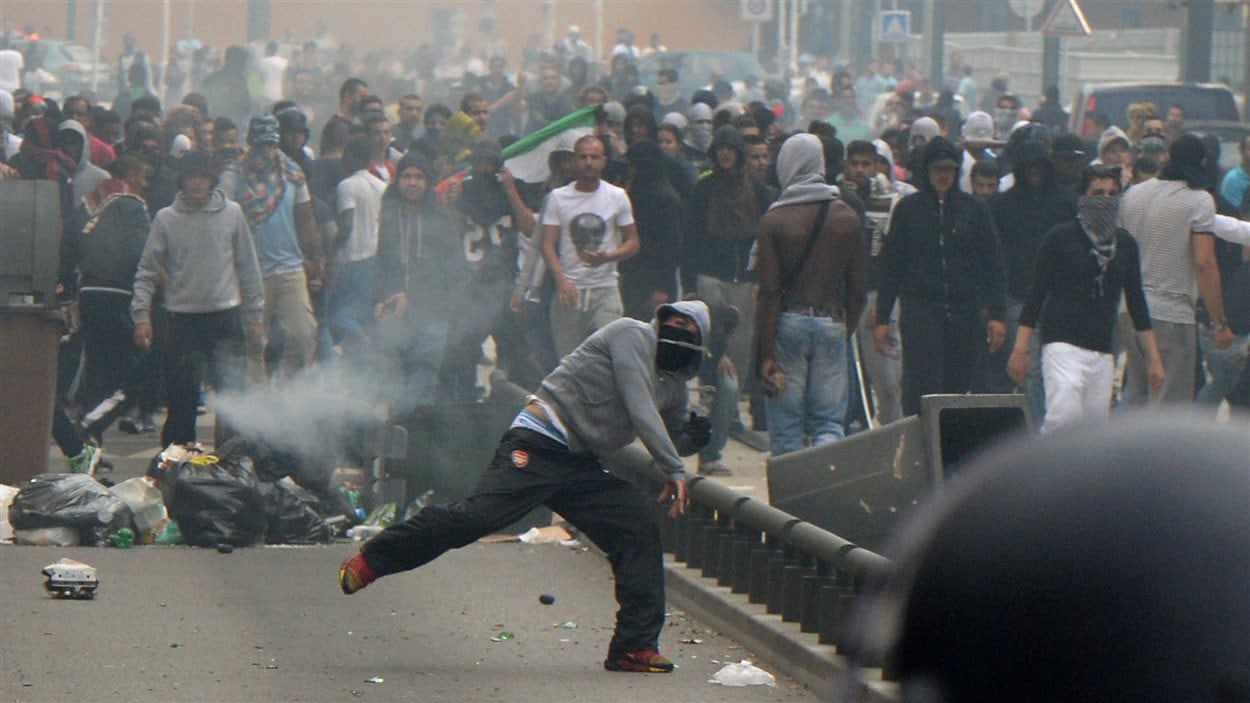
[768,313,848,457]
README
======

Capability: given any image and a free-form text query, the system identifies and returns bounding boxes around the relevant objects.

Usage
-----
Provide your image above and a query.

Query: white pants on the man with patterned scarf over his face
[1041,341,1115,433]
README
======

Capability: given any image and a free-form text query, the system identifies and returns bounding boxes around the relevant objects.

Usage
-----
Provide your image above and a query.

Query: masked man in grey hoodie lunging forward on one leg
[339,301,711,673]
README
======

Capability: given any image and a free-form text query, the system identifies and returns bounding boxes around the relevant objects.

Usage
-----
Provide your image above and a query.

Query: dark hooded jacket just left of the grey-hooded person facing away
[681,125,776,291]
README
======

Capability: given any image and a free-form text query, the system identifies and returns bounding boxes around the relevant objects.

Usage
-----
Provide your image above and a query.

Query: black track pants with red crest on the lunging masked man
[361,428,664,659]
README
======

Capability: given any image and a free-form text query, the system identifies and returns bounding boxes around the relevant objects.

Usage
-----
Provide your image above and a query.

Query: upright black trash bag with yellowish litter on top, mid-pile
[161,453,265,547]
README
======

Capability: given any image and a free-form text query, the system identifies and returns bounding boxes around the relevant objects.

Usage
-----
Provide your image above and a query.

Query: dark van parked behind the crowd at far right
[1069,83,1241,139]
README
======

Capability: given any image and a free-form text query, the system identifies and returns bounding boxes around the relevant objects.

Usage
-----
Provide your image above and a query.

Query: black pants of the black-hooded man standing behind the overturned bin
[899,298,986,415]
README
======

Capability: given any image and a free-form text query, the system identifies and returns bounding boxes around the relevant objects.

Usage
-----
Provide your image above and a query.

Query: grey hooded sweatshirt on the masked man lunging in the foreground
[538,300,711,479]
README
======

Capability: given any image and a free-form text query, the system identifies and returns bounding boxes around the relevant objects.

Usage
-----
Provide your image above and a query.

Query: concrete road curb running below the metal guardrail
[664,554,899,703]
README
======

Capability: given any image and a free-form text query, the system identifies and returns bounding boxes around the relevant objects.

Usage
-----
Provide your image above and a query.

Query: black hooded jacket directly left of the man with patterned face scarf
[990,141,1076,300]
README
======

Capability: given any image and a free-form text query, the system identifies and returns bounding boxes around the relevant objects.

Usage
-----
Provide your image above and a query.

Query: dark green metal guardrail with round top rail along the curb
[491,372,893,652]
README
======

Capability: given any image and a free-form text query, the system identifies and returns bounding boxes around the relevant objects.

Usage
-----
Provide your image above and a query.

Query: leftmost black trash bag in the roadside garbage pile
[9,474,135,547]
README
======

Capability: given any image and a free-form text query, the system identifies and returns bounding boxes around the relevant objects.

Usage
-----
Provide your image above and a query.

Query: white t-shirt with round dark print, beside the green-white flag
[543,180,634,289]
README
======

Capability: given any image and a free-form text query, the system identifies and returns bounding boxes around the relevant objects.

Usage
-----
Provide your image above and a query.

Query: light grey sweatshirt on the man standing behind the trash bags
[130,190,265,324]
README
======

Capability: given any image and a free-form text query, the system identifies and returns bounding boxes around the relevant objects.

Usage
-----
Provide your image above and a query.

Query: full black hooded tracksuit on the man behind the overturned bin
[876,138,1006,415]
